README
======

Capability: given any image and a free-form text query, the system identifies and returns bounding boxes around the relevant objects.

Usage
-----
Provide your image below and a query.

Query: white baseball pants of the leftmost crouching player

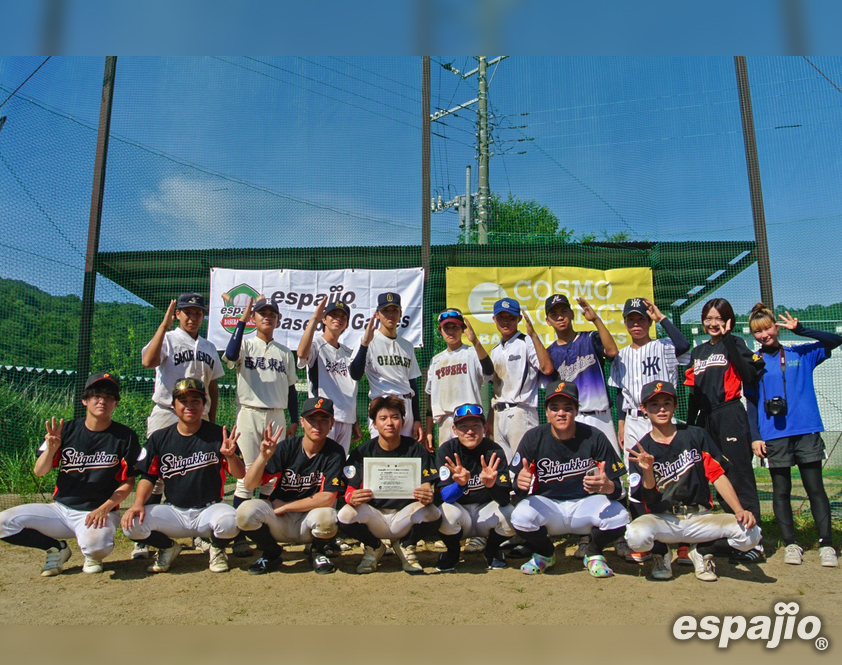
[0,501,120,561]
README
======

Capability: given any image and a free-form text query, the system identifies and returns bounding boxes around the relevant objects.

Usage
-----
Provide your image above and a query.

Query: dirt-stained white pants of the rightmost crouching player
[626,511,761,552]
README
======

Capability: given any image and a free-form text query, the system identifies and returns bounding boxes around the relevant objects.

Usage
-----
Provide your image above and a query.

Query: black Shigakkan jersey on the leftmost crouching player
[38,418,140,510]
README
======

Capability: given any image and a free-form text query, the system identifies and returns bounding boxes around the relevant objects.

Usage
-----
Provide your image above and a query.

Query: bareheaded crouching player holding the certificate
[339,395,441,573]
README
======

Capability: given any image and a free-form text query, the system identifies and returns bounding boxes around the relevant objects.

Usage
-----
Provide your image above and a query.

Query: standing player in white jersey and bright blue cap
[491,298,555,461]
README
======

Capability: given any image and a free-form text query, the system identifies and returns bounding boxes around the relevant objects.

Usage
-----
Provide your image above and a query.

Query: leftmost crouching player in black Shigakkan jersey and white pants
[0,373,140,577]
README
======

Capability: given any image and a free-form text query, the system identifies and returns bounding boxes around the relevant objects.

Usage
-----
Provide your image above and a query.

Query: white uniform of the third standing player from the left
[298,337,358,455]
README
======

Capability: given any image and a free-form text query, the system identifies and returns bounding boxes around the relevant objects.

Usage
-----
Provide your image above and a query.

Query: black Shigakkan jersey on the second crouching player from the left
[137,420,233,508]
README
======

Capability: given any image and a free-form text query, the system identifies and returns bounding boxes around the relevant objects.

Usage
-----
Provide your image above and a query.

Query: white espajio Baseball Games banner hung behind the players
[208,268,424,352]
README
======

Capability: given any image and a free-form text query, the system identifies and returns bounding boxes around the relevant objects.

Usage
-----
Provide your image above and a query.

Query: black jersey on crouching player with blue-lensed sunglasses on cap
[436,439,512,506]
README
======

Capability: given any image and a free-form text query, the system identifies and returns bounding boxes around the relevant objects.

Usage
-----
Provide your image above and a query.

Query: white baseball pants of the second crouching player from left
[123,502,239,540]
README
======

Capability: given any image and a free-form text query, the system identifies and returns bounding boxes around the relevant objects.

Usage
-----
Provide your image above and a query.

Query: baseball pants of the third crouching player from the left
[237,499,337,544]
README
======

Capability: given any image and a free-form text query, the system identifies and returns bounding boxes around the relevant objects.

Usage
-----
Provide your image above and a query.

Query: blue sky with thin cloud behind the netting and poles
[0,56,842,316]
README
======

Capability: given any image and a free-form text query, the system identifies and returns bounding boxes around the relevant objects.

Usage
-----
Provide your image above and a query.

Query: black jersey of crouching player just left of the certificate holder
[260,436,345,503]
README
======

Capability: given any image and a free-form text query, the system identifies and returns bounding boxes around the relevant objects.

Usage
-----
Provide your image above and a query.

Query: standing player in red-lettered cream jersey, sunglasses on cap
[426,308,494,450]
